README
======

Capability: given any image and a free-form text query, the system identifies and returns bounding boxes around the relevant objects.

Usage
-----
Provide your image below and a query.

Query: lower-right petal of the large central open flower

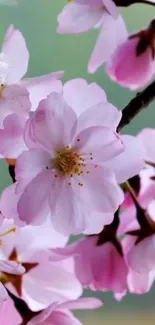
[72,165,123,213]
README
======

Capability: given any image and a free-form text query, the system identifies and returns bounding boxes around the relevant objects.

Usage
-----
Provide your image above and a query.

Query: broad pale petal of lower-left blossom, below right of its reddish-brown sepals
[23,252,82,311]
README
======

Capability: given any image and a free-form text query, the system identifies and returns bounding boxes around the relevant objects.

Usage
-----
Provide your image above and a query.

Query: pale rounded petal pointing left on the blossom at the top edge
[57,3,103,34]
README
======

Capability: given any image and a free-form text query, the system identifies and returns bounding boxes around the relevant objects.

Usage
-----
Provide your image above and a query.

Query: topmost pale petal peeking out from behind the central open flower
[63,79,106,115]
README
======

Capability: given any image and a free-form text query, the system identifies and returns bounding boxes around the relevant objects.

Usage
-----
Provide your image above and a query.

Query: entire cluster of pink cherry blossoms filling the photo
[0,0,155,325]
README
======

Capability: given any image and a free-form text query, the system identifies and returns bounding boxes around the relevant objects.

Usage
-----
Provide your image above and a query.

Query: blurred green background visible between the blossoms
[0,0,155,325]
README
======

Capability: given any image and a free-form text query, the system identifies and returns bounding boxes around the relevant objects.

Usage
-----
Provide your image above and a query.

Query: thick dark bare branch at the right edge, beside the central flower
[117,81,155,131]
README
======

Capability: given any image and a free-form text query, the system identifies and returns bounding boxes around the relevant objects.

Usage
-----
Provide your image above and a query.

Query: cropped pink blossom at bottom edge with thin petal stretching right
[28,298,103,325]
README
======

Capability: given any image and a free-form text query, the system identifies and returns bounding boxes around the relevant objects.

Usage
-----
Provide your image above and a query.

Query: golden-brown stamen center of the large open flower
[52,147,82,176]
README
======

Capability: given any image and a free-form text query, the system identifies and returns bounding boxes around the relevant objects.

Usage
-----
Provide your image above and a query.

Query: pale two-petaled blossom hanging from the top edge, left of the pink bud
[57,0,127,73]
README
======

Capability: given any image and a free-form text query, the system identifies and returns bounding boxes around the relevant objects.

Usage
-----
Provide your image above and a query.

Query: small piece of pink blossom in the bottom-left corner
[0,298,22,325]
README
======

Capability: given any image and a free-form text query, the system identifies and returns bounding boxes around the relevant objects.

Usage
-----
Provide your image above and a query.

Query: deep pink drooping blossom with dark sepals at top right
[106,25,155,89]
